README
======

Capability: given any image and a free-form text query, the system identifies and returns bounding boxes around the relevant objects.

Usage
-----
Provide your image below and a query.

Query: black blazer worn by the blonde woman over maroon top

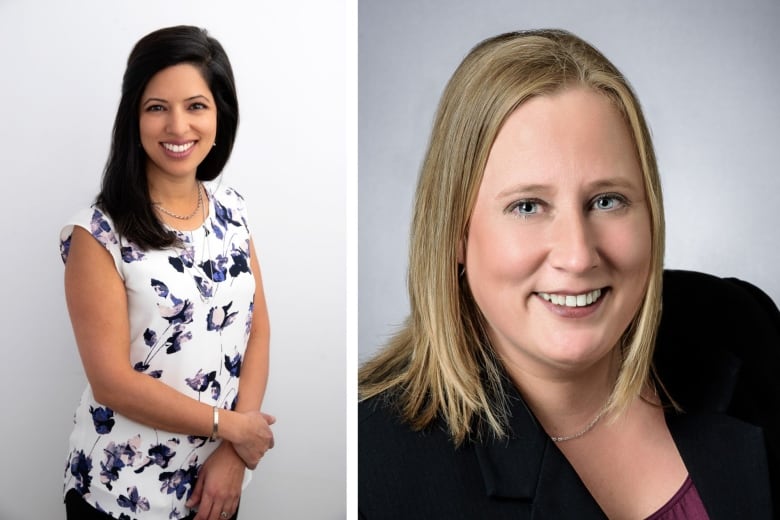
[358,271,780,520]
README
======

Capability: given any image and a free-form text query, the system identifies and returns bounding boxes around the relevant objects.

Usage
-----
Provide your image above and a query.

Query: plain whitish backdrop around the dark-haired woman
[0,0,354,520]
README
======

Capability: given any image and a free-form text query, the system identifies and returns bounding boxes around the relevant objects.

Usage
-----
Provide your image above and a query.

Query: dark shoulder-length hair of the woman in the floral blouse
[95,25,238,249]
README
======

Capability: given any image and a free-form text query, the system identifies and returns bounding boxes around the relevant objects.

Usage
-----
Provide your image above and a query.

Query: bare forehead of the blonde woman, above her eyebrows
[482,86,641,190]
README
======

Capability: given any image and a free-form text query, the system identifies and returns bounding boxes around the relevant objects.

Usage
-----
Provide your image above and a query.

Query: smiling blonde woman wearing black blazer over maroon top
[358,30,780,519]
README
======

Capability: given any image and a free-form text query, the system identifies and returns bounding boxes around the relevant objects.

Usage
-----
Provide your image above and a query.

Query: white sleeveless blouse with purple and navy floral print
[60,187,255,520]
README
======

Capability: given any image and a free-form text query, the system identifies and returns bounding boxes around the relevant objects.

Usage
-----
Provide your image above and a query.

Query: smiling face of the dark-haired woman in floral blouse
[139,64,217,183]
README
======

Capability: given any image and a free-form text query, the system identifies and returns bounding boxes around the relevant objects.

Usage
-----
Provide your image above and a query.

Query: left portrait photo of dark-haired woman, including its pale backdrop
[0,0,347,520]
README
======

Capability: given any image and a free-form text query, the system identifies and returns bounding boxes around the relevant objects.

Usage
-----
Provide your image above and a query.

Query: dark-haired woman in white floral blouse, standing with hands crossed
[61,26,274,520]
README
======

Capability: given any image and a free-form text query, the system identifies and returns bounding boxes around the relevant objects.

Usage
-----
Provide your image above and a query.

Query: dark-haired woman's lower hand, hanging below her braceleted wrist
[187,441,246,520]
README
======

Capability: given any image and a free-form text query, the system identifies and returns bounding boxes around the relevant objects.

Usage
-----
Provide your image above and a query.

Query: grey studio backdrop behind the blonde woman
[358,0,780,360]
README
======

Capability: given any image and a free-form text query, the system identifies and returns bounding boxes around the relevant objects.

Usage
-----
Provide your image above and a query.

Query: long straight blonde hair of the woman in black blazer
[359,30,664,444]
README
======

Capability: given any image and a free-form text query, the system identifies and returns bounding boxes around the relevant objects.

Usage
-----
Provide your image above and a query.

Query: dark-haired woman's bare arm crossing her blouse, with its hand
[65,227,270,463]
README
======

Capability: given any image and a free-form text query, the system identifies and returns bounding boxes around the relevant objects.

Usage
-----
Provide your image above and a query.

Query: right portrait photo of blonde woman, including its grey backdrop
[358,1,780,519]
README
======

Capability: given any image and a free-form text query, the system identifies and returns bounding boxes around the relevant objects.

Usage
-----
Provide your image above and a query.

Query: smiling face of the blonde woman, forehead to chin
[461,87,651,376]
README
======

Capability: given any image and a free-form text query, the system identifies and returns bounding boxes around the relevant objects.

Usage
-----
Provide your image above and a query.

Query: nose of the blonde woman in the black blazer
[548,211,600,274]
